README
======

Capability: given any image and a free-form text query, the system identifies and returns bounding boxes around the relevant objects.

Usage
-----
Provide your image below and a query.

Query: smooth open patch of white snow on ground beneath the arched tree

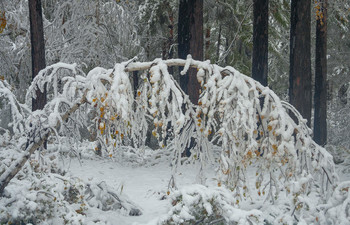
[67,150,215,225]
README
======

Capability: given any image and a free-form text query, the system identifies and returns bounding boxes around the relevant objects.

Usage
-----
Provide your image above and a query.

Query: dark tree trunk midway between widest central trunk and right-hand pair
[252,0,269,86]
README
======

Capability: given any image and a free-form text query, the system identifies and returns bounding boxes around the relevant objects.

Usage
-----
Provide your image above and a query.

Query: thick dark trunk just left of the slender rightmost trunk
[289,0,312,127]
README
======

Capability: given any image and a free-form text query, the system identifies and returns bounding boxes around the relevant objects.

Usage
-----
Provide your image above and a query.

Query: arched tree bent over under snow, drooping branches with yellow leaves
[1,56,336,219]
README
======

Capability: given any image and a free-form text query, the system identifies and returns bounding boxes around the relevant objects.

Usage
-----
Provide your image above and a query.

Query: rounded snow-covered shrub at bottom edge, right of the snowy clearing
[159,184,263,224]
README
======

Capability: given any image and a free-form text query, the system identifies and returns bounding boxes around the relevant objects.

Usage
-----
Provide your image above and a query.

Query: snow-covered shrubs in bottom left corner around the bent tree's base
[0,147,142,224]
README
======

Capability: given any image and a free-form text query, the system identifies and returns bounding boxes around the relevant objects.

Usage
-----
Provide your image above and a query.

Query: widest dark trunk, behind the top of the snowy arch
[178,0,204,104]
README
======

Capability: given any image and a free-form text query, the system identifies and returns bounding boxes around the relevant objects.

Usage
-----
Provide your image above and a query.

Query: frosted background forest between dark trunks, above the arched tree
[0,0,350,150]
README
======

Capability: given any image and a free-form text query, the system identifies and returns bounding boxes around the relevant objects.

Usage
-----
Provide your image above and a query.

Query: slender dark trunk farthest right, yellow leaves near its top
[314,0,327,146]
